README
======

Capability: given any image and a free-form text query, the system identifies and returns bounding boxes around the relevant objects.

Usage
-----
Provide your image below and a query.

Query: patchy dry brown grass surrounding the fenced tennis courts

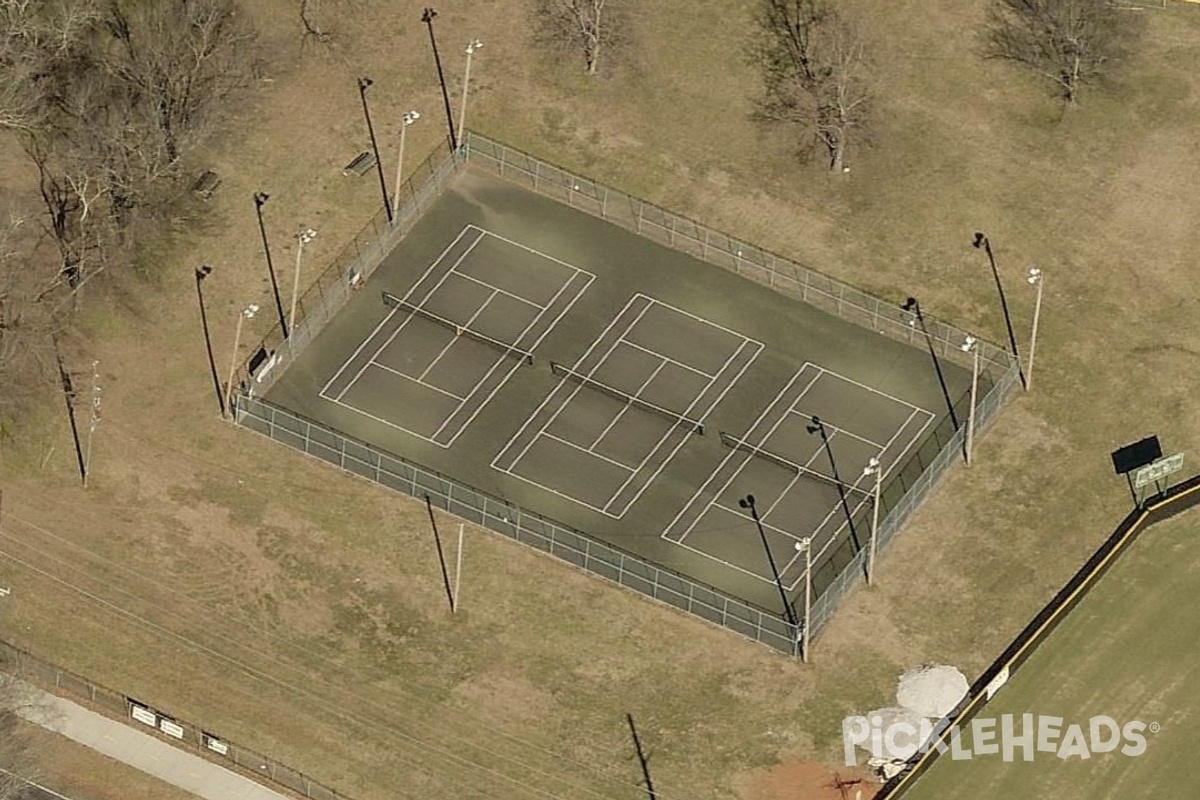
[0,0,1200,800]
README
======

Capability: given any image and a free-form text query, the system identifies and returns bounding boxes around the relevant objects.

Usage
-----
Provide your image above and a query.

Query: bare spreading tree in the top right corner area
[984,0,1128,106]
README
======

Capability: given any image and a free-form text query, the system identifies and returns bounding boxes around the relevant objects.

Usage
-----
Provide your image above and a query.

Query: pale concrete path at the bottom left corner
[18,685,292,800]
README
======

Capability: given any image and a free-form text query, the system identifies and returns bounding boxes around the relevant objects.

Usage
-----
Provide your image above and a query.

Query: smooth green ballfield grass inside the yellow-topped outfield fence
[905,511,1200,800]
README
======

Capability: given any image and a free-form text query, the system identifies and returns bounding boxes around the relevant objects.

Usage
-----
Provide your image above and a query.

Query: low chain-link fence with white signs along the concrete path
[0,642,346,800]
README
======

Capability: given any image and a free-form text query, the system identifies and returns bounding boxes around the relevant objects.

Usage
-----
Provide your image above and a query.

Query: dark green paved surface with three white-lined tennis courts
[258,170,970,609]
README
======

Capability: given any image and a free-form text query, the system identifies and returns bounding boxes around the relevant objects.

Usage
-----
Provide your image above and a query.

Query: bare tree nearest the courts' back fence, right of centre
[751,0,871,172]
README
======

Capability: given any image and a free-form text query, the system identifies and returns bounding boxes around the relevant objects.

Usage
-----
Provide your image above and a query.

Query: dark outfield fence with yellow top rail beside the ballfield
[875,475,1200,800]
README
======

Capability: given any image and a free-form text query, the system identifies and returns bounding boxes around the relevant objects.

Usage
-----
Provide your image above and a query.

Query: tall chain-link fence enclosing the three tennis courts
[235,133,1020,654]
